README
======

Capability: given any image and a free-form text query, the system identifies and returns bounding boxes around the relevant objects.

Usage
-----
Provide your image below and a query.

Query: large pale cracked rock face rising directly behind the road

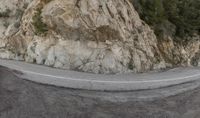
[0,0,165,73]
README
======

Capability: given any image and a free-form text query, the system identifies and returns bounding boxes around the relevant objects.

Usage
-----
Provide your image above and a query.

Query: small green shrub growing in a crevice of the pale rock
[32,8,48,35]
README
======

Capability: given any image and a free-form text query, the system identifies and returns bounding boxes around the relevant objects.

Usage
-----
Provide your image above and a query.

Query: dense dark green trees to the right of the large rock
[133,0,200,39]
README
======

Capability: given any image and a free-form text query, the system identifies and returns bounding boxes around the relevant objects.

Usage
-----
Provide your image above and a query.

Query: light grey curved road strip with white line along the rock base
[0,59,200,91]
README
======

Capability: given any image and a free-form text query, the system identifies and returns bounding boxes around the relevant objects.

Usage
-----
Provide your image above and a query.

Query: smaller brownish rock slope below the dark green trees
[158,35,200,66]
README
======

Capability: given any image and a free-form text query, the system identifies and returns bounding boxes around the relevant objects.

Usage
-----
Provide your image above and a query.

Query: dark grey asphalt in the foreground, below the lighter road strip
[0,67,200,118]
